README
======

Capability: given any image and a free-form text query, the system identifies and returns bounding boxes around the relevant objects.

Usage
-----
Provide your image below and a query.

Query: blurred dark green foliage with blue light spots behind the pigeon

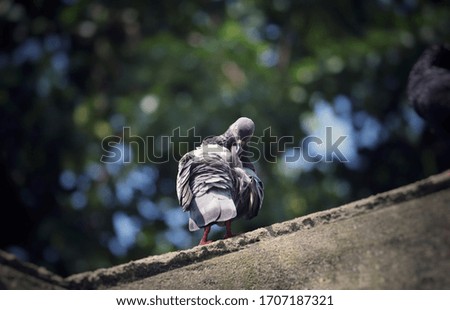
[0,0,450,275]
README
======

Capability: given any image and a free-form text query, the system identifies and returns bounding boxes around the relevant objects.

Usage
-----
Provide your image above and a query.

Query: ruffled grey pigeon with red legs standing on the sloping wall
[177,117,264,245]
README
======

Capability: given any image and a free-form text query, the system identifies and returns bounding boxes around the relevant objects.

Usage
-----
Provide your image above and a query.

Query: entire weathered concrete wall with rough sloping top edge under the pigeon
[0,171,450,289]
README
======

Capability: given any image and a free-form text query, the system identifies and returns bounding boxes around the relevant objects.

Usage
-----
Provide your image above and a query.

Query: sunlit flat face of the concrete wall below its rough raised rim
[115,191,450,289]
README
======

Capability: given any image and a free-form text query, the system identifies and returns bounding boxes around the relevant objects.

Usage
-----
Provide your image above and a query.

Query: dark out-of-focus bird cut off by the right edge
[407,44,450,137]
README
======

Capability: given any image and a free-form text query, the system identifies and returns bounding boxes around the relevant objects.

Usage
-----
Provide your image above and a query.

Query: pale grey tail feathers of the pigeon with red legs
[189,188,237,231]
